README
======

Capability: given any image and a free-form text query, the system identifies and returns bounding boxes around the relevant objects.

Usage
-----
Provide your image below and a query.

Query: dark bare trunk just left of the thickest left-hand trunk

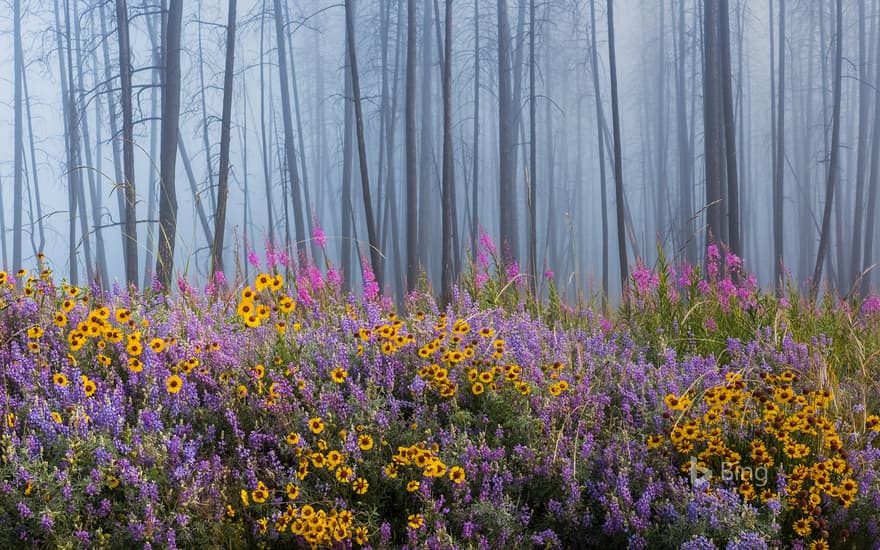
[116,0,138,288]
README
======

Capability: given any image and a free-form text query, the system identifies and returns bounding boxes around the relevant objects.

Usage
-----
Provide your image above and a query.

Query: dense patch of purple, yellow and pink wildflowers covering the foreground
[0,247,880,549]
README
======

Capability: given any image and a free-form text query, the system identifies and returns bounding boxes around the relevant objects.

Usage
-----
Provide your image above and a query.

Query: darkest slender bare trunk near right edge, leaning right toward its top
[810,0,843,298]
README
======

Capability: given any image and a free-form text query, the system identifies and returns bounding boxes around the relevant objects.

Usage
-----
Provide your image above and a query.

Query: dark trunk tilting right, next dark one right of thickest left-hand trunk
[211,0,236,280]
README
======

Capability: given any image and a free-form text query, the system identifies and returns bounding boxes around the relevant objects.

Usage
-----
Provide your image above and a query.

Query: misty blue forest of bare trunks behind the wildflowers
[0,0,880,297]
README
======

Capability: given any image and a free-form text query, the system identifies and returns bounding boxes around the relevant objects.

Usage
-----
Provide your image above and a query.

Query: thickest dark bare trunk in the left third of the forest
[156,0,183,292]
